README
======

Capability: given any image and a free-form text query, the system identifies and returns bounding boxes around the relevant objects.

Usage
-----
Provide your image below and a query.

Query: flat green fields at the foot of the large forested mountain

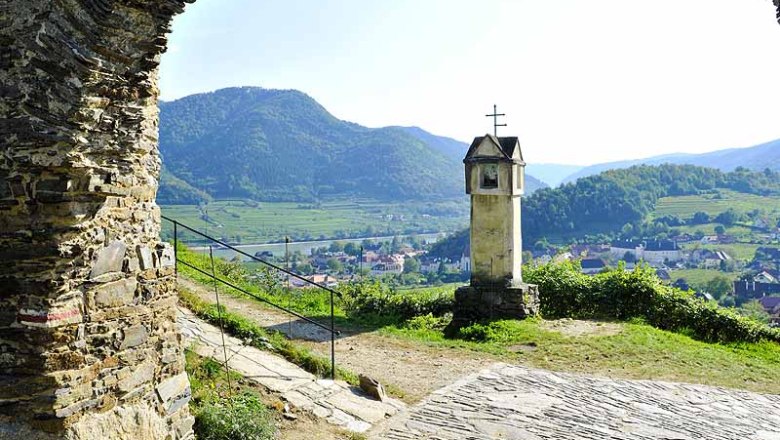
[162,199,468,244]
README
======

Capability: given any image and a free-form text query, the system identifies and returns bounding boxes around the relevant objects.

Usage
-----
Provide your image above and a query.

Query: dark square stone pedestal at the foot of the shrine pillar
[452,283,539,328]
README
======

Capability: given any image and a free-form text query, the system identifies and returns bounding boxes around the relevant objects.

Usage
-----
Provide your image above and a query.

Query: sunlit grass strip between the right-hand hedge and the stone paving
[382,319,780,393]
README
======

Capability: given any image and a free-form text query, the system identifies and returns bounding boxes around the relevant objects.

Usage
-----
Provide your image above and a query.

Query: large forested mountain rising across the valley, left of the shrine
[158,87,544,204]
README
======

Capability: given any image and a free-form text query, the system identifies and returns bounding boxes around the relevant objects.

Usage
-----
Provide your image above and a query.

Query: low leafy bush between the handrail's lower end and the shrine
[341,281,455,321]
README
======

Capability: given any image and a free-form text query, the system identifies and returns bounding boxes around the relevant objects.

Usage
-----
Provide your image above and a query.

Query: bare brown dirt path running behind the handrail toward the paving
[179,277,497,403]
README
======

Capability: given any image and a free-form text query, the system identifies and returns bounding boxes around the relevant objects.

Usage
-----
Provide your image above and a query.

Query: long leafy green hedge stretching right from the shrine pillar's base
[524,263,780,342]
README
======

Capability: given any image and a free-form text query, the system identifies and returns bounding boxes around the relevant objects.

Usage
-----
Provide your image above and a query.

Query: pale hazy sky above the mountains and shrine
[160,0,780,164]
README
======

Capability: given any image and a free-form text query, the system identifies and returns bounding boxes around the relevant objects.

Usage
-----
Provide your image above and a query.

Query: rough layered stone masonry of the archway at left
[0,0,193,440]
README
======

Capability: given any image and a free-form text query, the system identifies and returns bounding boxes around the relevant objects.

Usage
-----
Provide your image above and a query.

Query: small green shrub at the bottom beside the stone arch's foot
[194,391,276,440]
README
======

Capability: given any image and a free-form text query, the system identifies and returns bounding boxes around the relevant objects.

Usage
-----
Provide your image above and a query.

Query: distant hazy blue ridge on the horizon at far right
[563,139,780,183]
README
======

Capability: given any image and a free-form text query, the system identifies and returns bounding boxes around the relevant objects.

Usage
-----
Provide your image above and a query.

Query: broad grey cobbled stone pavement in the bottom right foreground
[374,364,780,440]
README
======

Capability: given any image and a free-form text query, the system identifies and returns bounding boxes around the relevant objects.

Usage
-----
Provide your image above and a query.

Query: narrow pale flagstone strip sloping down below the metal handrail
[178,307,405,432]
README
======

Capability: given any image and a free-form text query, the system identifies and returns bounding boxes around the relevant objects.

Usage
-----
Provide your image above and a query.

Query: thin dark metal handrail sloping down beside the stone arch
[161,215,342,380]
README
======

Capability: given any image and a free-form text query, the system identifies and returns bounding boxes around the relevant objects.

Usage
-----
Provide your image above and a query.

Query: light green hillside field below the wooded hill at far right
[653,189,780,218]
